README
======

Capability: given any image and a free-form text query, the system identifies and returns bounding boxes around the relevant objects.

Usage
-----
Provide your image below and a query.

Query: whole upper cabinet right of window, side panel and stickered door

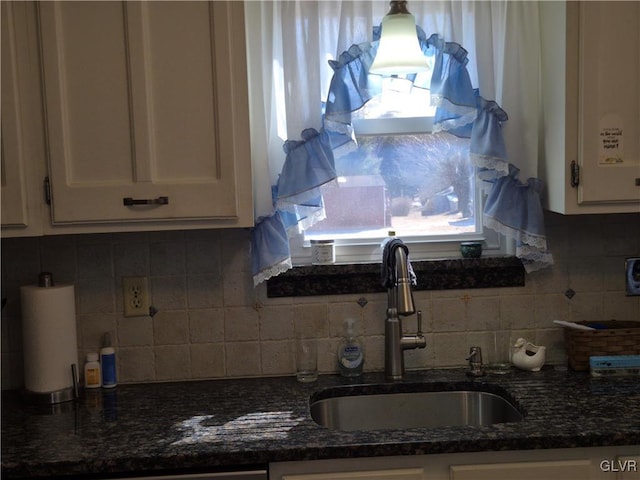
[540,1,640,214]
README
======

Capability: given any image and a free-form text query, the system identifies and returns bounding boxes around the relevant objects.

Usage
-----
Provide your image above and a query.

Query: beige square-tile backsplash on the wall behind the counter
[2,213,640,389]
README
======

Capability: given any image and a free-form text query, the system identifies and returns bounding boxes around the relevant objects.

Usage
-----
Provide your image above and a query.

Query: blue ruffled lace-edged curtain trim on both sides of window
[251,9,553,285]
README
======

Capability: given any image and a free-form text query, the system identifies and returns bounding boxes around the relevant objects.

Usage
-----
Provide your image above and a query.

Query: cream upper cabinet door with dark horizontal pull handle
[40,1,253,226]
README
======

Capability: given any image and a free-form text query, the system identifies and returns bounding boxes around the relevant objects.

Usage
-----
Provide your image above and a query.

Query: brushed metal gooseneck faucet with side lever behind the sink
[384,242,427,380]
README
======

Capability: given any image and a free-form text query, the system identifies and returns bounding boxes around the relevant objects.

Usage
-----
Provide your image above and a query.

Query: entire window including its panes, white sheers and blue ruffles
[246,1,548,284]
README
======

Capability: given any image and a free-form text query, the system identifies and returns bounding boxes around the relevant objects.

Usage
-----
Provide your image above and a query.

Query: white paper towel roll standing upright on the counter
[20,285,78,393]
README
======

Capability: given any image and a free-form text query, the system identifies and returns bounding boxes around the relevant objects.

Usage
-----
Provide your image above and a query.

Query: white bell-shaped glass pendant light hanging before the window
[369,0,427,75]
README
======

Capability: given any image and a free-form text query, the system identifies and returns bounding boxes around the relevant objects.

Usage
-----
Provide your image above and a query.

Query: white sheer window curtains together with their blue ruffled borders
[246,1,553,284]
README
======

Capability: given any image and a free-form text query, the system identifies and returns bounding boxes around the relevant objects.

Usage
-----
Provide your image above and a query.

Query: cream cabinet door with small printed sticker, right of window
[578,1,640,204]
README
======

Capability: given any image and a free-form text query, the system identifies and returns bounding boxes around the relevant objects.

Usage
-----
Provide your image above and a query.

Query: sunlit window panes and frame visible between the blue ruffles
[291,72,505,265]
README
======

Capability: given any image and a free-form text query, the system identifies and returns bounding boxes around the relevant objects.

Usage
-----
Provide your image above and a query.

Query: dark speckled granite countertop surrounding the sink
[2,368,640,479]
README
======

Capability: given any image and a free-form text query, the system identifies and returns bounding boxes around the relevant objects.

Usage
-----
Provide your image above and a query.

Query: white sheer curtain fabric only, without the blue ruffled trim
[245,0,541,217]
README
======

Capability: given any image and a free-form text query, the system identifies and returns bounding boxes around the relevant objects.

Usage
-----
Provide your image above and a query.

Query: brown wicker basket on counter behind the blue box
[564,320,640,371]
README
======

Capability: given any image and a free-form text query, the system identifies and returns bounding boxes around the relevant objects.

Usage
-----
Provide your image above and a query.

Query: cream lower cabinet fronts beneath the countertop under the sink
[269,445,640,480]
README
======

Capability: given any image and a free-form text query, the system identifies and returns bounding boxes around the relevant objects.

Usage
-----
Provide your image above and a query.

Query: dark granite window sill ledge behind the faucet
[267,257,525,297]
